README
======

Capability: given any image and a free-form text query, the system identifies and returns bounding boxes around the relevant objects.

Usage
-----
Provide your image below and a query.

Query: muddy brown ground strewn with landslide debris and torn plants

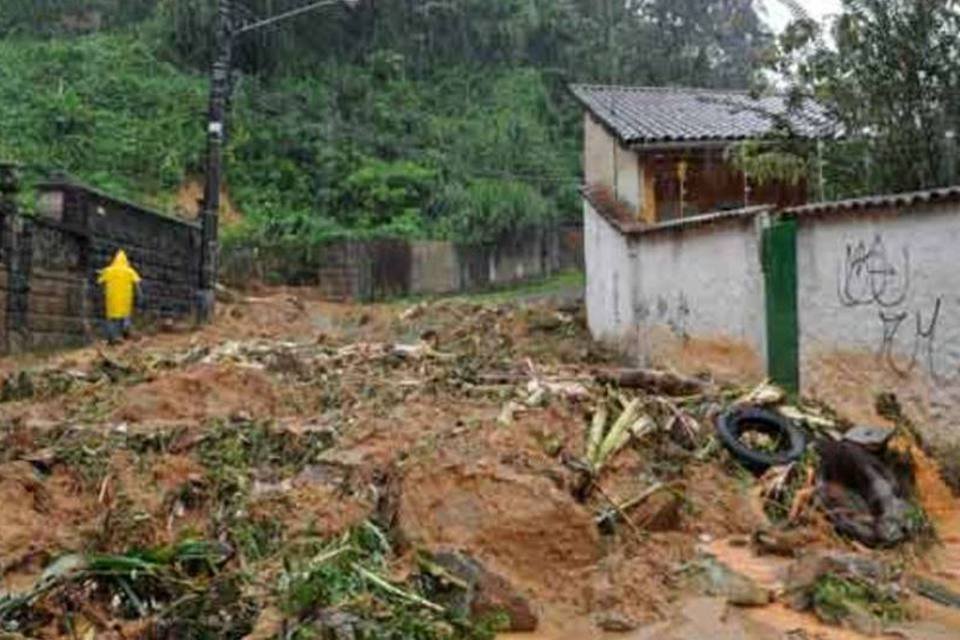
[0,291,960,640]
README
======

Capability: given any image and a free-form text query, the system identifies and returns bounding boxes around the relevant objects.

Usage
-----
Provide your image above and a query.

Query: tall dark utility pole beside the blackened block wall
[199,0,233,323]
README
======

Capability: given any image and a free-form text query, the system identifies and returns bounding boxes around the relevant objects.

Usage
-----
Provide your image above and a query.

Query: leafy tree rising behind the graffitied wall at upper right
[778,0,960,192]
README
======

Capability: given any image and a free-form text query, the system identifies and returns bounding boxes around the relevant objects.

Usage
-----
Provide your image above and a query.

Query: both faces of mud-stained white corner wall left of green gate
[584,203,766,378]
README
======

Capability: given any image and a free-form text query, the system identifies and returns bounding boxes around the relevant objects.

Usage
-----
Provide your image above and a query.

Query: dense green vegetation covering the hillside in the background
[0,0,770,240]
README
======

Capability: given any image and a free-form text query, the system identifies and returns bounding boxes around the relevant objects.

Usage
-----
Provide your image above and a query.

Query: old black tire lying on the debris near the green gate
[717,407,807,473]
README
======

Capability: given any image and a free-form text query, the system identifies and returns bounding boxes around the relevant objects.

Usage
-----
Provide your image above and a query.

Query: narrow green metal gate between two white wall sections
[763,218,800,393]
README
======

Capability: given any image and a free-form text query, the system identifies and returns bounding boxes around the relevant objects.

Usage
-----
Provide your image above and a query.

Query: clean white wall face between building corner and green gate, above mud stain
[636,217,766,367]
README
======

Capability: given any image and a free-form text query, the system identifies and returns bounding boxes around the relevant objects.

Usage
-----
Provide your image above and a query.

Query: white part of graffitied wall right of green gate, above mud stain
[797,207,960,364]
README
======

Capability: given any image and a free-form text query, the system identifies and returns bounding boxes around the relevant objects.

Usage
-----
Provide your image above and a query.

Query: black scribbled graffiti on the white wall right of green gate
[837,234,948,380]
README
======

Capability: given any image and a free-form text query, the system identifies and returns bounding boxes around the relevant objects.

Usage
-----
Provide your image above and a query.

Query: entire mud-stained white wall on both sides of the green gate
[585,190,960,450]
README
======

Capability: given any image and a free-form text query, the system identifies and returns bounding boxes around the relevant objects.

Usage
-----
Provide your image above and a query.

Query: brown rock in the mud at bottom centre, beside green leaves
[422,552,540,632]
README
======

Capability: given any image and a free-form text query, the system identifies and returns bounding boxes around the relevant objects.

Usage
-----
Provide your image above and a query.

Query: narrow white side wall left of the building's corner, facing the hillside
[583,202,636,350]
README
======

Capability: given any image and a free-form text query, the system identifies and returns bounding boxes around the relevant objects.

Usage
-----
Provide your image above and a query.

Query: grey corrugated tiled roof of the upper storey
[570,85,838,145]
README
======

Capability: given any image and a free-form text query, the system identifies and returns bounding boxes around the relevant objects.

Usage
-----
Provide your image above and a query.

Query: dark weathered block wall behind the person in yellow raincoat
[0,169,200,353]
